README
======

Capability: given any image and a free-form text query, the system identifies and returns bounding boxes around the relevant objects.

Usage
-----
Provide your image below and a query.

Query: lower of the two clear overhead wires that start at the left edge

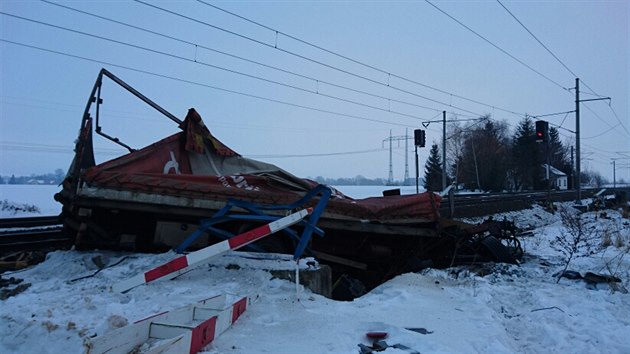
[0,38,414,128]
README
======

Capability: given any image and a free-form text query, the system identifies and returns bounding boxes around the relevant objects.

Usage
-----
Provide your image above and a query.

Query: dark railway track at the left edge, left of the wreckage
[0,216,70,254]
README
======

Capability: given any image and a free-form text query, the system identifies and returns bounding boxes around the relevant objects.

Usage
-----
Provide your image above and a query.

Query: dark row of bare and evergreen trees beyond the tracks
[424,116,605,192]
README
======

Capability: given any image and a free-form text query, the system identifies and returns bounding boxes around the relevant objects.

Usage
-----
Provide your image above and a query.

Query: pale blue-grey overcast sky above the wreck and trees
[0,0,630,181]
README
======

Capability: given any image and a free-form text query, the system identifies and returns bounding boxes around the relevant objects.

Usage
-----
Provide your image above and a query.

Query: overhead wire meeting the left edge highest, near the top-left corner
[0,12,444,124]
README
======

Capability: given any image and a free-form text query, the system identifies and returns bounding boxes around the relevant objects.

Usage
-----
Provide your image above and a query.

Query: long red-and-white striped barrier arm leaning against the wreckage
[112,208,313,292]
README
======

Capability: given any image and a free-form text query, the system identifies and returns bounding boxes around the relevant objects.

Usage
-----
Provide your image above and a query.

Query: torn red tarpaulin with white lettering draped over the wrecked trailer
[84,109,441,221]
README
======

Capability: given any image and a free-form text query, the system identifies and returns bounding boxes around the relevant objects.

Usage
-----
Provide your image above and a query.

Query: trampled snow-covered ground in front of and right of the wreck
[0,187,630,353]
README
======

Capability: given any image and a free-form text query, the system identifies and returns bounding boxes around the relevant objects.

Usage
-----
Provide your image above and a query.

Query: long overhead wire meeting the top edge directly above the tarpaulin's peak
[197,0,524,116]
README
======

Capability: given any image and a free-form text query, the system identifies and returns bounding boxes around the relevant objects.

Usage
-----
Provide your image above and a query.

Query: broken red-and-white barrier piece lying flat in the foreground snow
[84,295,251,354]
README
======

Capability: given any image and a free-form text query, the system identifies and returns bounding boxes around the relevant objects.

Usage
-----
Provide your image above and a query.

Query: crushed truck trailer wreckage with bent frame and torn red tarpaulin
[55,69,521,296]
